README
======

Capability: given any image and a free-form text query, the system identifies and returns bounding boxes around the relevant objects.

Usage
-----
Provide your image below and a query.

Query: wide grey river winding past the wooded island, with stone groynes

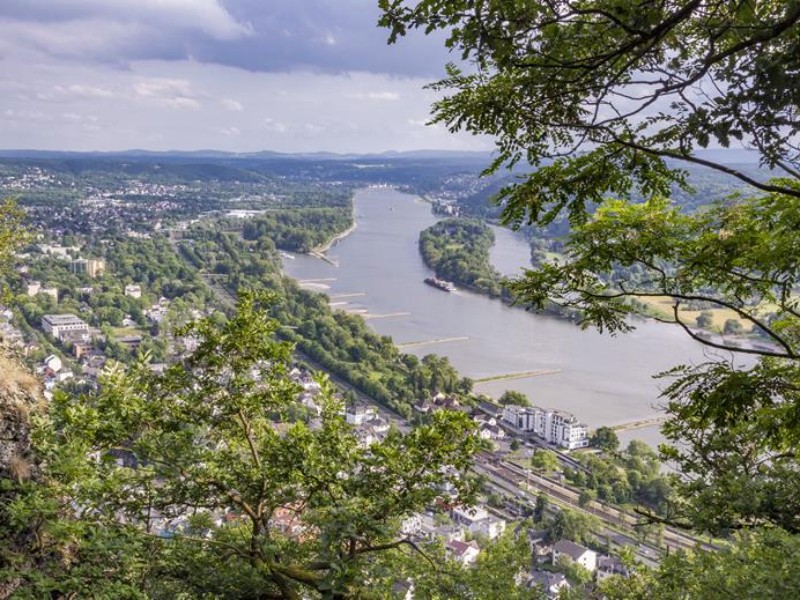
[283,189,736,444]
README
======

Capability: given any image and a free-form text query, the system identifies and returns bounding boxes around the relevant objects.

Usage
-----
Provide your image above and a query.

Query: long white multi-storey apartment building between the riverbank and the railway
[503,404,589,450]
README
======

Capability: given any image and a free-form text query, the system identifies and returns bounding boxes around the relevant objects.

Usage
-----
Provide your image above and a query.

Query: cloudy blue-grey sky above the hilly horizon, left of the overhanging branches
[0,0,490,152]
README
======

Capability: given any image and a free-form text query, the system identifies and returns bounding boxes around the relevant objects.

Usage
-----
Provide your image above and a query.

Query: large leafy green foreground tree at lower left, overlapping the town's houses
[7,294,479,598]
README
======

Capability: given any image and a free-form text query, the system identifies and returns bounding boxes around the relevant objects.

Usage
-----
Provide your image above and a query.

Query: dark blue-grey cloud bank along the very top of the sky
[0,0,452,78]
